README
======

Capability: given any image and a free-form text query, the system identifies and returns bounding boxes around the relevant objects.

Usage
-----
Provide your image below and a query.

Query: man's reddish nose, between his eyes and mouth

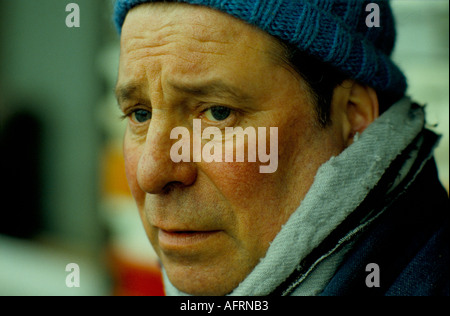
[137,119,197,194]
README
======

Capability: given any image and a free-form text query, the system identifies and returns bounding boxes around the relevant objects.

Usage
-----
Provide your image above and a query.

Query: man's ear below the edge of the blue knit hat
[333,80,379,146]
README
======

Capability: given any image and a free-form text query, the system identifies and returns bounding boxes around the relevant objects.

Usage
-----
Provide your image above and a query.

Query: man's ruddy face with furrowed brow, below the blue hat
[117,4,343,295]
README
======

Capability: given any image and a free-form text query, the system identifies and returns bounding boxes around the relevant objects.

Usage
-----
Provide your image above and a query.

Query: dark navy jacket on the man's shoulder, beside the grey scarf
[272,129,450,296]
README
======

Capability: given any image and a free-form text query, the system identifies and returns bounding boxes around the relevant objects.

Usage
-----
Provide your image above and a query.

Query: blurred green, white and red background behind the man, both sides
[0,0,449,295]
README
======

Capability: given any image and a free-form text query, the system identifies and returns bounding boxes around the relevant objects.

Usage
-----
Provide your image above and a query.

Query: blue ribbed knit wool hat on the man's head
[114,0,407,97]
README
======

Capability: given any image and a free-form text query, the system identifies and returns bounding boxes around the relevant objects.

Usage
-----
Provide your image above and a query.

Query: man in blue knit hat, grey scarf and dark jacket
[111,0,449,295]
